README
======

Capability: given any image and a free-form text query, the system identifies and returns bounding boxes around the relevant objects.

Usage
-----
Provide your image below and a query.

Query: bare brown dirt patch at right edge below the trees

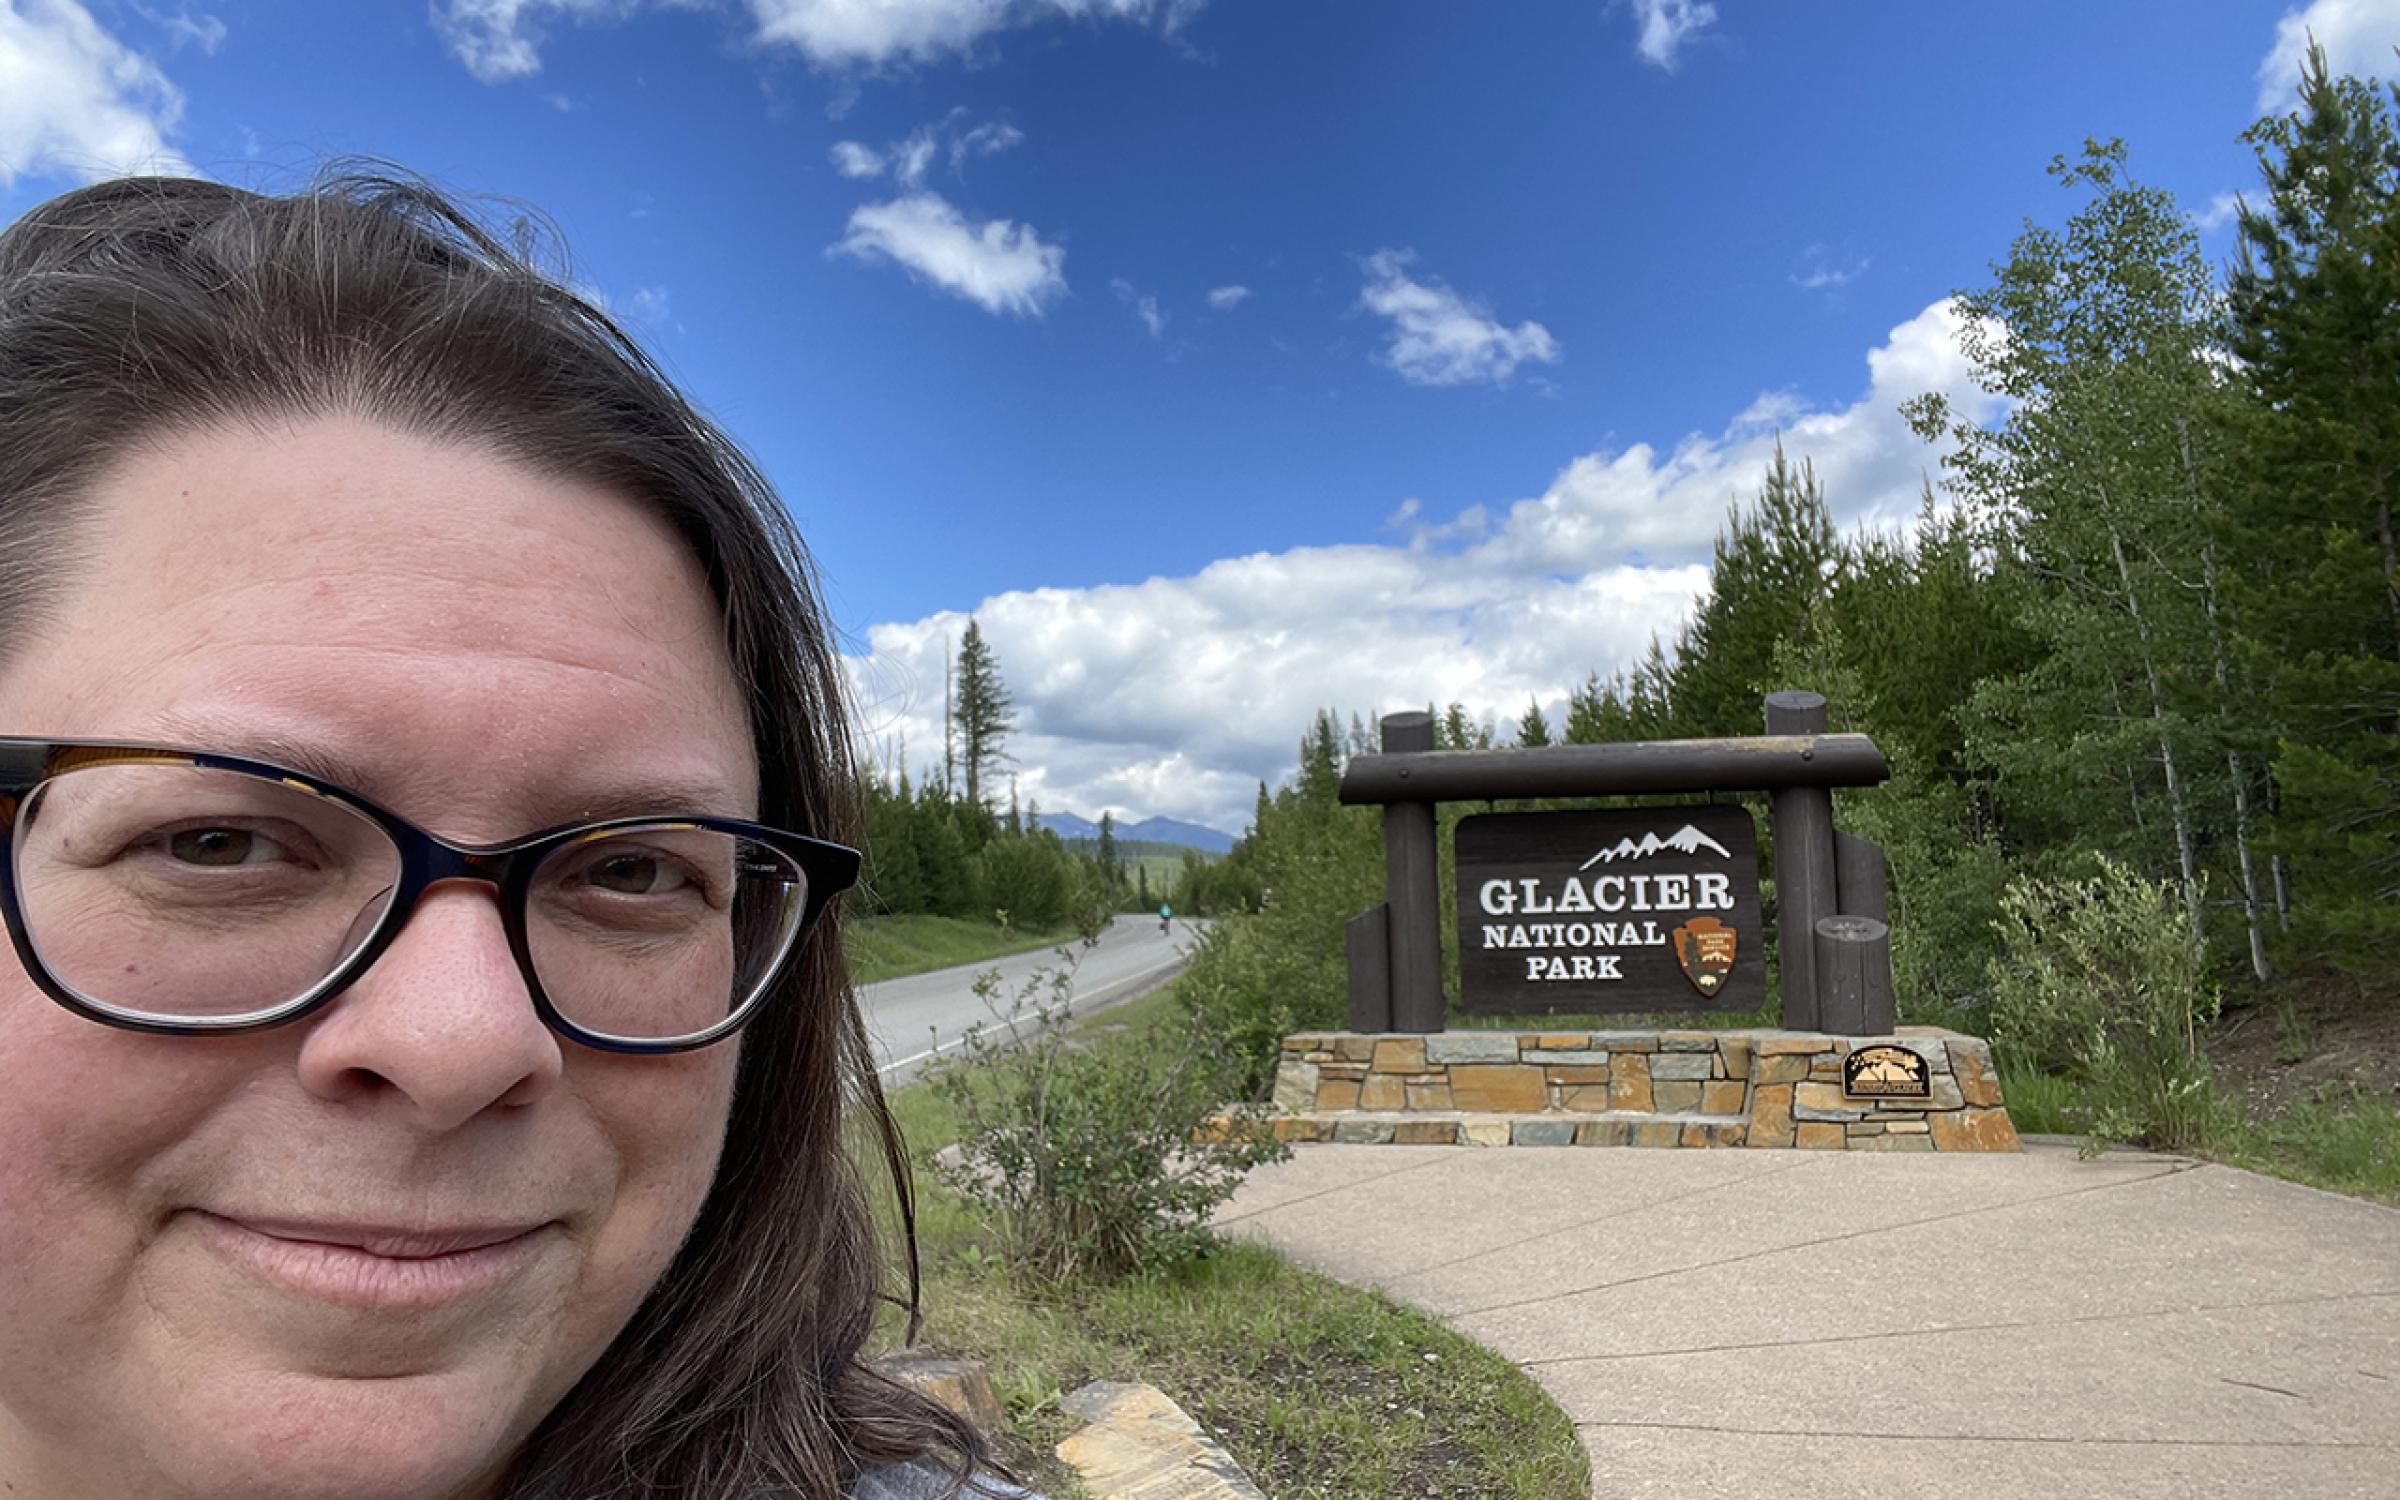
[2208,974,2400,1118]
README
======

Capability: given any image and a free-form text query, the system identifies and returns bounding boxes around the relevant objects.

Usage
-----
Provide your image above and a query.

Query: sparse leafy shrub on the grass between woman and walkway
[929,948,1291,1284]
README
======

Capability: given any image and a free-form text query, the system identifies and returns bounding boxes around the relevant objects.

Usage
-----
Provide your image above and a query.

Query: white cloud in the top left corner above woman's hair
[0,0,194,187]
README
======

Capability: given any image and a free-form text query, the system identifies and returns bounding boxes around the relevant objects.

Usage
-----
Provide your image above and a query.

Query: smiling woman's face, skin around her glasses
[0,420,758,1500]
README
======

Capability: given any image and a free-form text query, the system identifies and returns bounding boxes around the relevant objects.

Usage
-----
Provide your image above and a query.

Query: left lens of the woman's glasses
[14,766,401,1025]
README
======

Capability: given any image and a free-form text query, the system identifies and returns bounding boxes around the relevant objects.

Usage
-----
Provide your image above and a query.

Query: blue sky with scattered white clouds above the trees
[0,0,2400,828]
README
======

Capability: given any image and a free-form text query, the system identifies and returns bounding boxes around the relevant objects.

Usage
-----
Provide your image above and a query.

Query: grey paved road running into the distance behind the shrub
[859,917,1195,1087]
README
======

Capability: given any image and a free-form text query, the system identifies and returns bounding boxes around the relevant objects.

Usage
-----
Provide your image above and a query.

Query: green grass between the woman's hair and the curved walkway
[893,989,1591,1500]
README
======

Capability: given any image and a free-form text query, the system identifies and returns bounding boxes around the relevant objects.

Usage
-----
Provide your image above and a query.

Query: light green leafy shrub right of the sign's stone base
[1990,857,2218,1150]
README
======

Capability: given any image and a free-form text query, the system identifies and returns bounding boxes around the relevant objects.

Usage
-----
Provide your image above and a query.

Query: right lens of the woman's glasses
[526,823,809,1042]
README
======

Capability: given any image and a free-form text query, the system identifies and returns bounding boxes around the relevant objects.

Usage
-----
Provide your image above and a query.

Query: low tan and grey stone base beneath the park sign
[1267,1027,2018,1152]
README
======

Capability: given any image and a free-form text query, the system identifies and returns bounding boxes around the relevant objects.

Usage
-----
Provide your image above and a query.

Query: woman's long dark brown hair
[0,170,984,1500]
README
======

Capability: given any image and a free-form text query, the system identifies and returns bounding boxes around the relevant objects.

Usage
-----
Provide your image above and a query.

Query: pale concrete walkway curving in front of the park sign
[1219,1138,2400,1500]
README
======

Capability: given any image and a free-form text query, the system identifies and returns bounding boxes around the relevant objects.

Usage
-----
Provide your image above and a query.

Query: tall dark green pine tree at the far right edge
[2227,46,2400,962]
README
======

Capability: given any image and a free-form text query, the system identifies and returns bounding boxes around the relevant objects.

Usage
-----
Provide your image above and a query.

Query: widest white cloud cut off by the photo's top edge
[749,0,1202,67]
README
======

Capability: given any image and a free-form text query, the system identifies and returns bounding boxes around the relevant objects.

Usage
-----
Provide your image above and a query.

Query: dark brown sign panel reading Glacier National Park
[1457,806,1766,1015]
